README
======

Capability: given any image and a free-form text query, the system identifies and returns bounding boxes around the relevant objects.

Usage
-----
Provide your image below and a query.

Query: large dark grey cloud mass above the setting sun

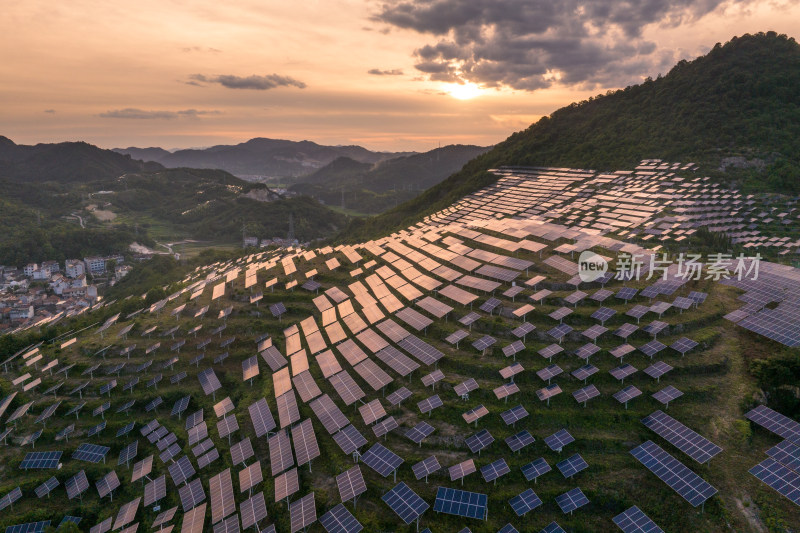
[372,0,755,91]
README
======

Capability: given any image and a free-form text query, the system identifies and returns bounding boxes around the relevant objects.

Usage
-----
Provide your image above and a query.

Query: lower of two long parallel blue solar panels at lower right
[631,441,717,507]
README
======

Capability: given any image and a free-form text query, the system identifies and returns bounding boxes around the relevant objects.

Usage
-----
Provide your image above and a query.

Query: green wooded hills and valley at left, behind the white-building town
[0,137,347,265]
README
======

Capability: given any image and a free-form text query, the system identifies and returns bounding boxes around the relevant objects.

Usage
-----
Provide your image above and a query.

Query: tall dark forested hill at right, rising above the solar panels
[340,32,800,240]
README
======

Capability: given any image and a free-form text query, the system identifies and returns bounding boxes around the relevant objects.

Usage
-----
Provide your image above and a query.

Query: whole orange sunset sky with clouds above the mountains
[0,0,800,151]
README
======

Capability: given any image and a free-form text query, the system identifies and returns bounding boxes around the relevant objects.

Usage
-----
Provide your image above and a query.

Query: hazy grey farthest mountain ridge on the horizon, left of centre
[113,138,414,178]
